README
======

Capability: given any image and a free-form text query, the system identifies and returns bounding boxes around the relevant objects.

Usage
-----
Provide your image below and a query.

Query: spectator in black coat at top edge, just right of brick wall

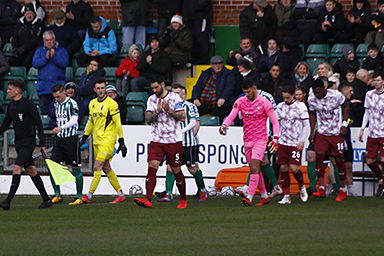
[239,0,277,45]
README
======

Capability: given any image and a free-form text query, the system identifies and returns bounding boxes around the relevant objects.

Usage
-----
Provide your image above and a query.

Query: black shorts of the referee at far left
[15,138,36,168]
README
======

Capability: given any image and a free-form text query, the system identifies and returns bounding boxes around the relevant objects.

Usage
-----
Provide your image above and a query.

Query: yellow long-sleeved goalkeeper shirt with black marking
[84,97,123,144]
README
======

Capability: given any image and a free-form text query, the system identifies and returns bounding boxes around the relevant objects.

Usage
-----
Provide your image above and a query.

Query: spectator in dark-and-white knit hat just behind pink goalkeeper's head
[234,57,259,98]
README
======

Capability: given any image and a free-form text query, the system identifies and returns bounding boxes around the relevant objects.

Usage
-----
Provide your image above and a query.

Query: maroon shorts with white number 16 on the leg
[315,133,344,158]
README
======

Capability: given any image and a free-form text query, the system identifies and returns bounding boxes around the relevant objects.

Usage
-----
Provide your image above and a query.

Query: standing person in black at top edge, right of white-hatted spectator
[182,0,212,64]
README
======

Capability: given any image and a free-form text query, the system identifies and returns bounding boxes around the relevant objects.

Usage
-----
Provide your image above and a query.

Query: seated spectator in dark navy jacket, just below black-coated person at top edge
[256,38,283,73]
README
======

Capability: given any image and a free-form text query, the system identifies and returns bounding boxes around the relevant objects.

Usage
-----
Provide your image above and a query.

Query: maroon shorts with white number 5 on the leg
[148,141,183,167]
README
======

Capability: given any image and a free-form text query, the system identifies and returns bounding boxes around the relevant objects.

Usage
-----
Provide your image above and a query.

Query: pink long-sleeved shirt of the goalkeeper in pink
[223,95,279,147]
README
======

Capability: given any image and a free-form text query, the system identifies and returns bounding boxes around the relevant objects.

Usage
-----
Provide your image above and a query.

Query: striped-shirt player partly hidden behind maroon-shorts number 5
[157,84,208,202]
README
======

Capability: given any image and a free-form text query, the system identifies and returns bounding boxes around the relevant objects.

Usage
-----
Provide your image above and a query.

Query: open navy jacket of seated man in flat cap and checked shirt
[192,67,236,101]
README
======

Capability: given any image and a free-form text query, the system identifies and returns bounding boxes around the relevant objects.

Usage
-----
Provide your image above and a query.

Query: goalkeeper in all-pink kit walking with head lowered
[219,80,279,206]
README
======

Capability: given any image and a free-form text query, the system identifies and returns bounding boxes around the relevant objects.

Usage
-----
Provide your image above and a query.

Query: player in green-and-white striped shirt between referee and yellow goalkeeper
[51,84,83,205]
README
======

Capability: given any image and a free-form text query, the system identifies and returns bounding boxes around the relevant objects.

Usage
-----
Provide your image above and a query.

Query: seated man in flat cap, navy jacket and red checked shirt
[191,56,236,122]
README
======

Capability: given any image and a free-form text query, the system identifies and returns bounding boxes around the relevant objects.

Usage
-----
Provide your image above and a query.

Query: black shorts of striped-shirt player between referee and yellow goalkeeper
[51,135,81,166]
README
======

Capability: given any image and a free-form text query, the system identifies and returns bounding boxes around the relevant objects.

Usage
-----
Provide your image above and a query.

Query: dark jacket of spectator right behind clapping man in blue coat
[48,22,81,56]
